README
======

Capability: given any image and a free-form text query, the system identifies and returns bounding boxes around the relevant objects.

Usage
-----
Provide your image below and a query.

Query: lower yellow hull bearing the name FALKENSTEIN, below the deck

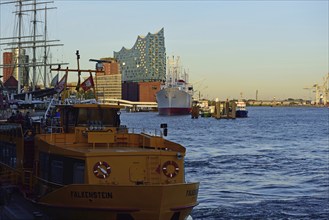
[37,183,199,220]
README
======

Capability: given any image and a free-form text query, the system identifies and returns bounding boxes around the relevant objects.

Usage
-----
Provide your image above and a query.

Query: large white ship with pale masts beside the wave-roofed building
[156,57,193,115]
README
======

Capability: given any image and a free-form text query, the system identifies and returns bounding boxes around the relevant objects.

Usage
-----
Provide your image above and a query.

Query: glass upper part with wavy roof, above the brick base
[114,28,166,83]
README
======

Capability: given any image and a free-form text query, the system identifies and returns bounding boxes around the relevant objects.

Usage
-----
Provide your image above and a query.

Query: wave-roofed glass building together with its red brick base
[114,28,166,102]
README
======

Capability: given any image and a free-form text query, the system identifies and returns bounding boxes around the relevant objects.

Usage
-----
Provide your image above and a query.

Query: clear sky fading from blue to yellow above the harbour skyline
[0,0,329,100]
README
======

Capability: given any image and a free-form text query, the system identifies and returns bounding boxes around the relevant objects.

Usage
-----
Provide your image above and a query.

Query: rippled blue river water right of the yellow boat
[121,107,329,220]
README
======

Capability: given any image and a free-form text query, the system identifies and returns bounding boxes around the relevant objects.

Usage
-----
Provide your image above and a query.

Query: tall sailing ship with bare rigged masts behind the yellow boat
[0,0,65,120]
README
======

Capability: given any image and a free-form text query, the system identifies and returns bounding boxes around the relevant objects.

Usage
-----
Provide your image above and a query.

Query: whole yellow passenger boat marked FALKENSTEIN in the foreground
[0,104,199,220]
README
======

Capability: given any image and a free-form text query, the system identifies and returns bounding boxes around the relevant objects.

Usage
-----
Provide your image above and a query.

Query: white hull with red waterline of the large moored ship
[156,88,192,115]
